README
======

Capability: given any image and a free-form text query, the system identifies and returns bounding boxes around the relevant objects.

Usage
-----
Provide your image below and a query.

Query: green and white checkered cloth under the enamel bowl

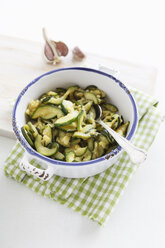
[4,89,164,225]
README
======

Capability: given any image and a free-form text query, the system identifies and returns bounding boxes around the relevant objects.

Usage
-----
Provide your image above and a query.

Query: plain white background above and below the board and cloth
[0,0,165,248]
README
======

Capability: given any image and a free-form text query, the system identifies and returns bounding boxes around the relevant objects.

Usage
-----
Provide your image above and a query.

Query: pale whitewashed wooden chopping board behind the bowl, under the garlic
[0,35,157,138]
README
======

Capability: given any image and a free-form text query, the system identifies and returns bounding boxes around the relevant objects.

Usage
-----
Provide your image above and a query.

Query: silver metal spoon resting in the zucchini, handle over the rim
[93,104,147,164]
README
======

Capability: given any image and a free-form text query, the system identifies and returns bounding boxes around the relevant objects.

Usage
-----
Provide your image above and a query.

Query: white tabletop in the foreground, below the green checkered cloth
[0,123,165,248]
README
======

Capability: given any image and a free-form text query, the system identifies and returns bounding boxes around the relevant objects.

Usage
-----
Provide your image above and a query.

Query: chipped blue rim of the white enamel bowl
[12,67,138,166]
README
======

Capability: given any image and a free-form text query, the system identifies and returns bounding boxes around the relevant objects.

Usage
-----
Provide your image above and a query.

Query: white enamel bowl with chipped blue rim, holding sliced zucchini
[13,67,138,180]
